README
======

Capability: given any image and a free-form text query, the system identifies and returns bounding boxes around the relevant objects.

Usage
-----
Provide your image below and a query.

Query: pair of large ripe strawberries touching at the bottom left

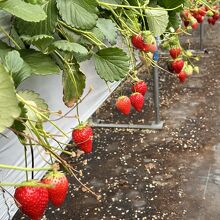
[14,171,69,220]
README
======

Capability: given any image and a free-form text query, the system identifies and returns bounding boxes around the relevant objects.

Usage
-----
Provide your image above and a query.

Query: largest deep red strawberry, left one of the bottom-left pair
[14,181,49,220]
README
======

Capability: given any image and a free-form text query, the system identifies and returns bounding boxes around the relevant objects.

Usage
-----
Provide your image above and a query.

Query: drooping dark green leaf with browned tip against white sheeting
[63,63,86,108]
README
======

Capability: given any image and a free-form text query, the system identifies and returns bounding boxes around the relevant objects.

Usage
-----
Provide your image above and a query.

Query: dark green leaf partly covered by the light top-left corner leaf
[15,0,58,36]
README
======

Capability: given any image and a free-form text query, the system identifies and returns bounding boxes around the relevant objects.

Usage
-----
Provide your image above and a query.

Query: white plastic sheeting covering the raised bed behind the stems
[0,24,119,220]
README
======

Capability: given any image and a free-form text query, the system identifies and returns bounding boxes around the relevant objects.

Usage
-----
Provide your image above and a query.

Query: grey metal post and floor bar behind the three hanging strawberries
[91,47,164,130]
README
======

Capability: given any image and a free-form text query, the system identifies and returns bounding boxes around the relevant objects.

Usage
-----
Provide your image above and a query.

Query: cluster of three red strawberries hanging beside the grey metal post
[115,80,147,115]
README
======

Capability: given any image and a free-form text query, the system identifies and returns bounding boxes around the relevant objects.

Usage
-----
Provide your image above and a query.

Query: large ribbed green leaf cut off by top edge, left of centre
[57,0,98,30]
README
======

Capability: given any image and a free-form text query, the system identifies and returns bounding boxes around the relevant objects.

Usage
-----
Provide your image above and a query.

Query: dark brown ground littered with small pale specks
[13,24,220,220]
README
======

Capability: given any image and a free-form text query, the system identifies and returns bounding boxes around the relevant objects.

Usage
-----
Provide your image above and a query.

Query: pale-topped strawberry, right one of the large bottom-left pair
[42,171,69,207]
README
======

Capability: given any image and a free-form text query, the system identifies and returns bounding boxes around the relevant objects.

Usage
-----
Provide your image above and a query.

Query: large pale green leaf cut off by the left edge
[0,65,21,132]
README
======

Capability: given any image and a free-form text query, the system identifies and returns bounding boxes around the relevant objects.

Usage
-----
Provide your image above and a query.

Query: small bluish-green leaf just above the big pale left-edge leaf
[5,50,24,73]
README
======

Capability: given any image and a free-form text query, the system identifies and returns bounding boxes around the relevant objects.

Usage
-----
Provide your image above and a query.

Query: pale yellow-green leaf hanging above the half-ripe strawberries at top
[145,7,169,36]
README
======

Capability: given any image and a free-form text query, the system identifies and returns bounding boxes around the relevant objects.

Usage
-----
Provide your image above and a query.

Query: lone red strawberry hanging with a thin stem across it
[72,124,93,153]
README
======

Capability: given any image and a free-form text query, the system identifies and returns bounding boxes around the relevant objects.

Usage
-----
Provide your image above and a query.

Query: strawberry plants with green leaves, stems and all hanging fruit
[0,0,219,220]
